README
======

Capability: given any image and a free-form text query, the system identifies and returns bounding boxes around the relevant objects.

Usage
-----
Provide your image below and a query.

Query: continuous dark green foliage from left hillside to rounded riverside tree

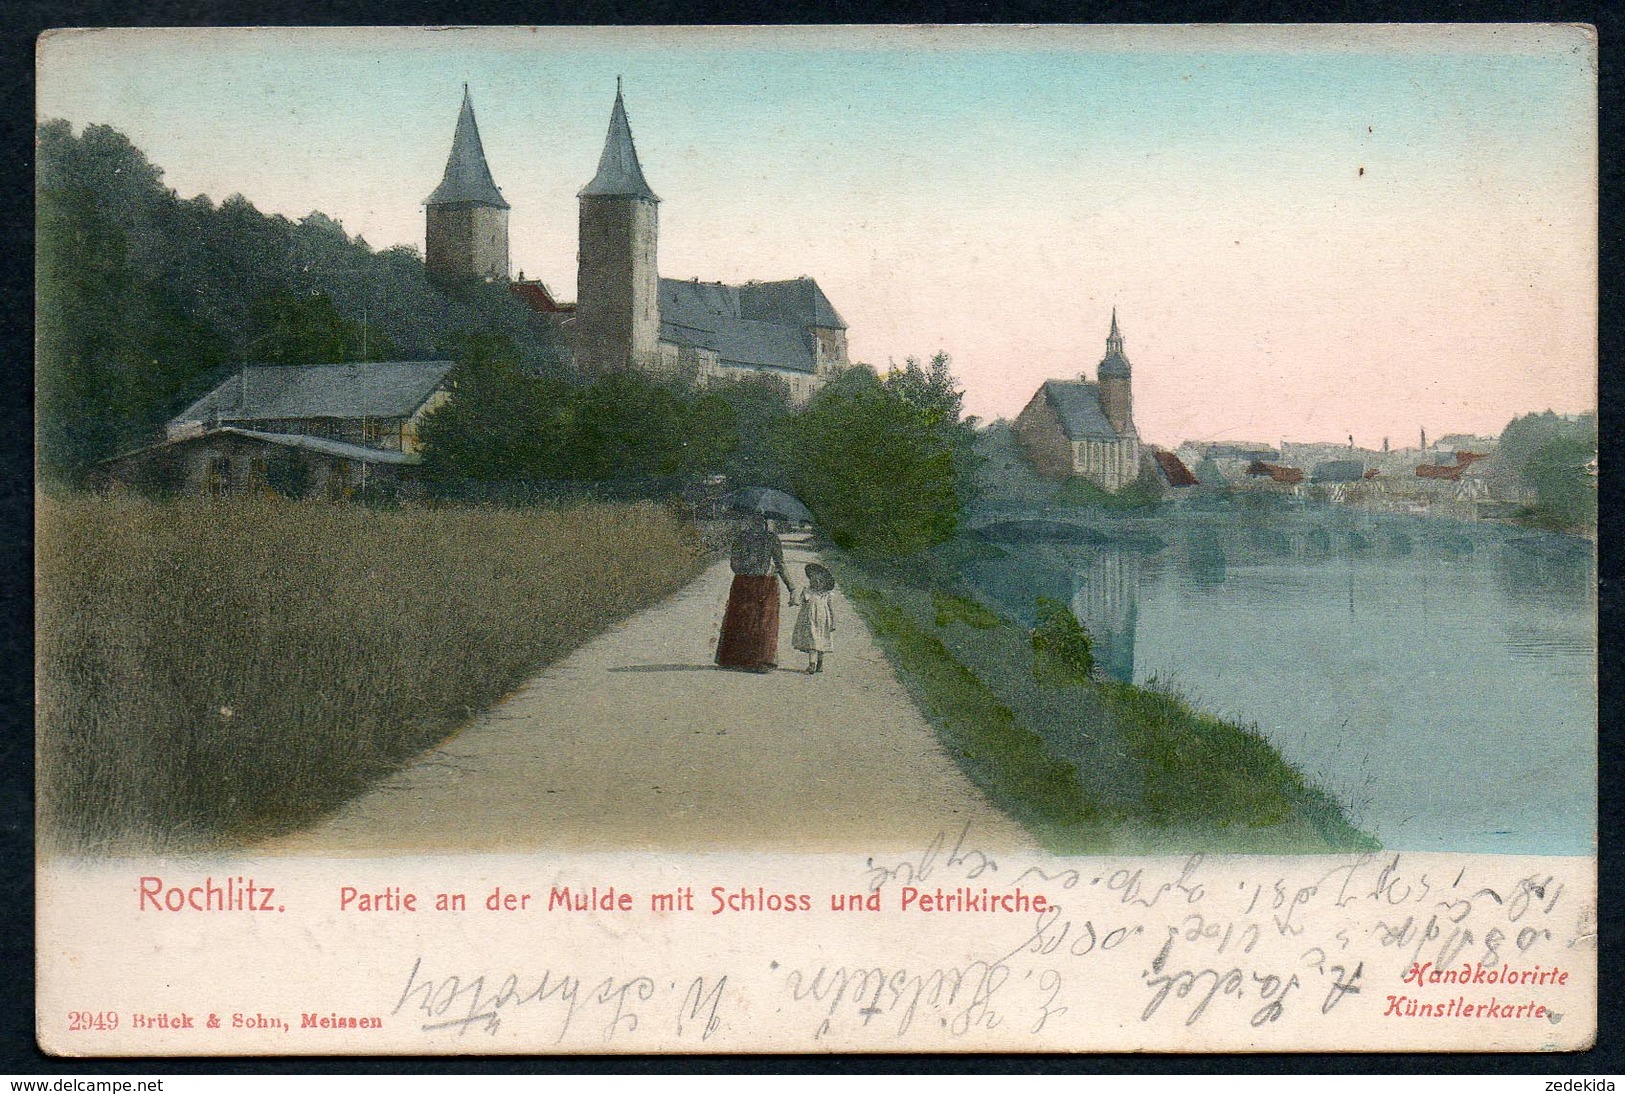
[37,122,977,542]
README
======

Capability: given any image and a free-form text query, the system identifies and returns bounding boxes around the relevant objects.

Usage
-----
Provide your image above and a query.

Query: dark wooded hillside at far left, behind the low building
[36,120,564,480]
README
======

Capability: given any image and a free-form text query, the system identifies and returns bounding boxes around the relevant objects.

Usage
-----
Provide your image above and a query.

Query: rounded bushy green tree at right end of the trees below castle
[785,366,965,556]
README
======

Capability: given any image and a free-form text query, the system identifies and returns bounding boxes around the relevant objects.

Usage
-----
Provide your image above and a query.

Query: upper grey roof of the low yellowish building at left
[171,361,452,424]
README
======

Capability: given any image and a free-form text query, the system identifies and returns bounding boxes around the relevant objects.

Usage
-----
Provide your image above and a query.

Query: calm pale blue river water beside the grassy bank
[967,509,1597,855]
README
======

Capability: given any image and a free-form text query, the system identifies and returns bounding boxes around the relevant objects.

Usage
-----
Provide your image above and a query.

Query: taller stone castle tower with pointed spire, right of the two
[574,78,660,377]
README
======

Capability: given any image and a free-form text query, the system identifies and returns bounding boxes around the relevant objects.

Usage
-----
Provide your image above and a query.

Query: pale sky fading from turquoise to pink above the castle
[37,24,1597,447]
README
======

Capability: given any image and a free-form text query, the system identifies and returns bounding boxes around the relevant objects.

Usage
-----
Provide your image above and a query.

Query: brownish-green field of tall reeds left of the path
[36,496,704,852]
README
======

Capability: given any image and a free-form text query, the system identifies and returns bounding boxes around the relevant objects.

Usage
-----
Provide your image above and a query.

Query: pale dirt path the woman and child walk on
[262,540,1034,855]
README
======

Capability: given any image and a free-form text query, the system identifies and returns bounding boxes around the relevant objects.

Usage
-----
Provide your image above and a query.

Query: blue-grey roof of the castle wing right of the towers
[660,278,845,372]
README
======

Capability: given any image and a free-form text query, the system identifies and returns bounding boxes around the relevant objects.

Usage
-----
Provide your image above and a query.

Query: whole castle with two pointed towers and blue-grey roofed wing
[424,80,848,403]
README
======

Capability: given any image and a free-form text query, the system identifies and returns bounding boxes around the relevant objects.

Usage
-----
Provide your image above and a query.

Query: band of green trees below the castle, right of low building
[423,336,975,542]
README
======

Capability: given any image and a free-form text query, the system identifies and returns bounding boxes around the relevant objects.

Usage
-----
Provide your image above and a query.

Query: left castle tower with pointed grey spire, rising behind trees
[423,83,509,281]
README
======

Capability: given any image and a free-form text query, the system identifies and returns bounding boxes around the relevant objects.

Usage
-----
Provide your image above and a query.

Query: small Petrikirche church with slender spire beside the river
[1016,307,1141,493]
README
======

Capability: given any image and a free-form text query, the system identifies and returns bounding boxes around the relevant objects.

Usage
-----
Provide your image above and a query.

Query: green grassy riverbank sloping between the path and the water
[837,546,1376,853]
